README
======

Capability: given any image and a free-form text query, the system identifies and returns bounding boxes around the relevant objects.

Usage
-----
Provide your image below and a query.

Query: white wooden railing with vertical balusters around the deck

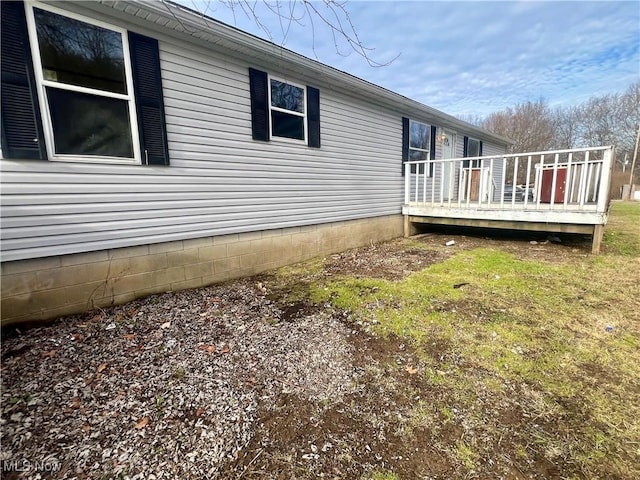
[404,146,613,213]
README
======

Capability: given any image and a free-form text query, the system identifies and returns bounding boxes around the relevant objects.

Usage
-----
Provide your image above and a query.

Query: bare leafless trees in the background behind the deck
[464,81,640,181]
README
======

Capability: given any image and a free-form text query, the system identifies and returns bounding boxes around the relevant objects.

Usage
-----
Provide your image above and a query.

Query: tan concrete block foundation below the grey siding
[1,215,403,325]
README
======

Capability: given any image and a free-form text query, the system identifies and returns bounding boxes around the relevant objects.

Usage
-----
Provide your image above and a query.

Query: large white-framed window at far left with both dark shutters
[0,2,169,165]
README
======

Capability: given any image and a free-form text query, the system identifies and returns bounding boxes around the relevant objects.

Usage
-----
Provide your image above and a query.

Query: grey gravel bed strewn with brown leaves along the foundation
[0,280,357,479]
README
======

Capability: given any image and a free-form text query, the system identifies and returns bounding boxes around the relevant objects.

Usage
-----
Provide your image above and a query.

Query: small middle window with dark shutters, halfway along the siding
[249,68,320,148]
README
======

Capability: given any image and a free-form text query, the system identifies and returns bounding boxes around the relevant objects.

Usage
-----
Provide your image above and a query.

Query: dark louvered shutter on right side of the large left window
[129,32,169,165]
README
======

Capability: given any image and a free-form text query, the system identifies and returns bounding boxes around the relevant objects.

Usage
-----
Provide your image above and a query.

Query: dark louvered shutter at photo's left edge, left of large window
[0,1,47,160]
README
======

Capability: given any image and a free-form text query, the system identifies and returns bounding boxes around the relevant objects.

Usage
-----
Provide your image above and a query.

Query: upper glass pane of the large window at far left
[33,8,127,94]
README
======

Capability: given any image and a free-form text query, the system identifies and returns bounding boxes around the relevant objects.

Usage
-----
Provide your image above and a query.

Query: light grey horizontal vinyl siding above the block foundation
[0,23,402,261]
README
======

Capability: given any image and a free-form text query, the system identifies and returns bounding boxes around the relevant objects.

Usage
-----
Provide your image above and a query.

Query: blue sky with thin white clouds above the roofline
[181,0,640,119]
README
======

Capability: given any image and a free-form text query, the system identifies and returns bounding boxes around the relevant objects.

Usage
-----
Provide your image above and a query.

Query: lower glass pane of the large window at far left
[47,87,133,158]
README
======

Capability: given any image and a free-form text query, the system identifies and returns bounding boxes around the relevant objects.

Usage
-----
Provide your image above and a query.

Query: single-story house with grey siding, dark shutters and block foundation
[0,0,509,325]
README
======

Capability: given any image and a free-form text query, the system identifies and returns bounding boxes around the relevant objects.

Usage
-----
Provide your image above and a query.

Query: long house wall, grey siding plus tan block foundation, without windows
[0,2,510,324]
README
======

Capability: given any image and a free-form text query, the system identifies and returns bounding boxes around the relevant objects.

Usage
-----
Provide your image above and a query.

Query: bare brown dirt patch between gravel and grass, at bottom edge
[225,332,460,479]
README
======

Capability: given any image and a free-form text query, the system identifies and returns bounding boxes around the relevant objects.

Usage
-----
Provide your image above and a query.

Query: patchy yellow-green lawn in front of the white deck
[302,203,640,478]
